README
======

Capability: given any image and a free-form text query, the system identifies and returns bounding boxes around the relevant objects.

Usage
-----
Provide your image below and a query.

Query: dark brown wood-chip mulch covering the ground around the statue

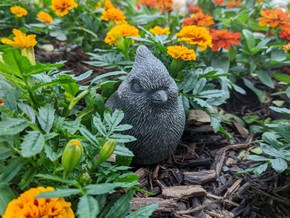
[36,44,290,218]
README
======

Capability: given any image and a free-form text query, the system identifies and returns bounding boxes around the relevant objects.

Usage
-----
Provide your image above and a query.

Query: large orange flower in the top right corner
[257,9,290,29]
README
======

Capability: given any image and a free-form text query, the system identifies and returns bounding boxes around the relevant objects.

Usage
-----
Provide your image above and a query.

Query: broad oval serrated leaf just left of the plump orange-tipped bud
[21,131,45,157]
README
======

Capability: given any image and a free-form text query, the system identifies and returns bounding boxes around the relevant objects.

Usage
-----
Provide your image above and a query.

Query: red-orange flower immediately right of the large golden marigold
[210,29,241,51]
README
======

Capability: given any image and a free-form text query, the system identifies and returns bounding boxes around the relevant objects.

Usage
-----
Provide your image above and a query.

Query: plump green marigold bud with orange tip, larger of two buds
[61,139,84,178]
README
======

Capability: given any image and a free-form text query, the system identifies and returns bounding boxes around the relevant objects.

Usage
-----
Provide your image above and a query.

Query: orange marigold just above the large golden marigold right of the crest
[182,12,214,27]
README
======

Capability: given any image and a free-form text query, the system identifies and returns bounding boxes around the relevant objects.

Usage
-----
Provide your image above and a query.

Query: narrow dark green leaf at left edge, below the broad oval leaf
[0,158,27,183]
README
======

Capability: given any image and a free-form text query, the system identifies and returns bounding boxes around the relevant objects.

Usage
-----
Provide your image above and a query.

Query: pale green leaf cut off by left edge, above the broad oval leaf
[0,118,29,136]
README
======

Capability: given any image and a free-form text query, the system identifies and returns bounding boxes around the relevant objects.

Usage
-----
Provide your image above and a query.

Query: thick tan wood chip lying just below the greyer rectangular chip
[162,185,206,199]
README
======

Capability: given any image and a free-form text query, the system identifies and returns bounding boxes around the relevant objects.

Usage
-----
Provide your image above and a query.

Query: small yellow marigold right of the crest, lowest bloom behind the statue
[167,45,196,61]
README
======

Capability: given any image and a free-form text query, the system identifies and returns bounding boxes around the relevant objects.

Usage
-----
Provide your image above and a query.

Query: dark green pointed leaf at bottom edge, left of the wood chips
[105,190,134,218]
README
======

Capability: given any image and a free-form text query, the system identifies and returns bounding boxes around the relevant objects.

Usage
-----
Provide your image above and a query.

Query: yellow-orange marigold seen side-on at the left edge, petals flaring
[1,29,37,48]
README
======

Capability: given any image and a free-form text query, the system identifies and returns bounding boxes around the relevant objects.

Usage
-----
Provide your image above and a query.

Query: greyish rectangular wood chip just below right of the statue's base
[183,170,216,185]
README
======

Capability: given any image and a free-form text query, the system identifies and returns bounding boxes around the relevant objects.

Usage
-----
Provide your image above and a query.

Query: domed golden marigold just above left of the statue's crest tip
[105,24,140,45]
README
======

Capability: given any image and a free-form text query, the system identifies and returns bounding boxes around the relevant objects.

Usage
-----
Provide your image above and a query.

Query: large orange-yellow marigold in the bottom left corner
[3,187,75,218]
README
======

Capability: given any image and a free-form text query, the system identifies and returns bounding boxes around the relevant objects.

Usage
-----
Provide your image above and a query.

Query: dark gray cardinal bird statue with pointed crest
[106,45,185,165]
